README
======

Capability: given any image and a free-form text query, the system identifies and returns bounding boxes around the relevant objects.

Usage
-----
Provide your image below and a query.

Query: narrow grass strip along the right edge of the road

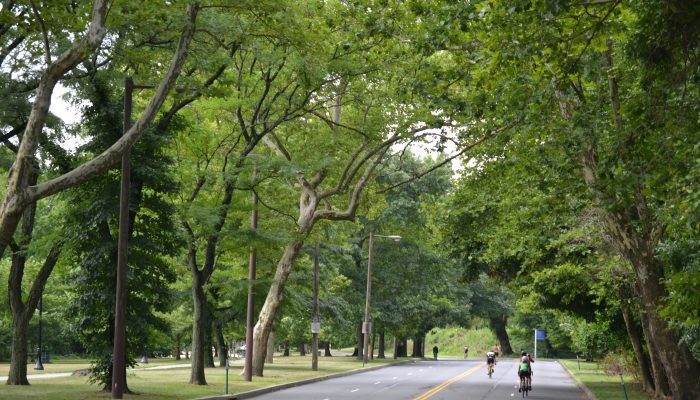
[561,360,651,400]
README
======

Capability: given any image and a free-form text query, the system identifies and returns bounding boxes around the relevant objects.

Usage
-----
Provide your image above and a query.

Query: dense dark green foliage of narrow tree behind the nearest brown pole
[64,76,179,386]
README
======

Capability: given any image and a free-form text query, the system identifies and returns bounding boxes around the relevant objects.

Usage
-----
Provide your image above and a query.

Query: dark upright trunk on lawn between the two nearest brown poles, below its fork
[190,271,207,385]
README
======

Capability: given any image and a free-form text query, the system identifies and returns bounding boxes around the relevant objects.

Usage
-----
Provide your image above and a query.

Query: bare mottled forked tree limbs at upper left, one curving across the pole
[0,0,198,262]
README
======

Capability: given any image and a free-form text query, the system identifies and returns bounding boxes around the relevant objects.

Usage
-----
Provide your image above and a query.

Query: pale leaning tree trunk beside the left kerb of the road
[253,240,304,376]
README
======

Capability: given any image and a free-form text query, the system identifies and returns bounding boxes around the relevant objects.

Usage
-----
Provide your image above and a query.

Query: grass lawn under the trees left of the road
[0,356,402,400]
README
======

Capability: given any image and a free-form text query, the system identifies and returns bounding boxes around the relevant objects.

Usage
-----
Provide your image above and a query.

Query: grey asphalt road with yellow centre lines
[249,360,587,400]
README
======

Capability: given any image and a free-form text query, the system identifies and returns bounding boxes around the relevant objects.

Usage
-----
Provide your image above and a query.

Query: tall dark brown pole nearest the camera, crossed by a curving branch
[112,77,134,399]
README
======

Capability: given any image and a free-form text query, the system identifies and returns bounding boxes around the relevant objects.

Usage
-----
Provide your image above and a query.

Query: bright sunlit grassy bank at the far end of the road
[425,327,496,358]
